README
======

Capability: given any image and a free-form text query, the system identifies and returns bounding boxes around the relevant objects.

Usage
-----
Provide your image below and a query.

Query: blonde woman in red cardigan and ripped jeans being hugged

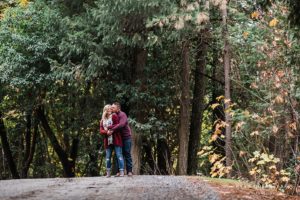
[100,105,124,177]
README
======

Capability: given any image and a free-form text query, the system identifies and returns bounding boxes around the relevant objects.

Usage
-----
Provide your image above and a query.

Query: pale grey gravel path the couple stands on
[0,176,220,200]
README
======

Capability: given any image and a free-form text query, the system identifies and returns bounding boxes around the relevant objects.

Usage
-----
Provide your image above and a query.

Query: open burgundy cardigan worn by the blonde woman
[100,114,123,149]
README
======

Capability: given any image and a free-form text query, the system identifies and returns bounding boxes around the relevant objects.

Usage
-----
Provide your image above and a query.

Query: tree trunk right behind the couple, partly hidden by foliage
[132,48,147,175]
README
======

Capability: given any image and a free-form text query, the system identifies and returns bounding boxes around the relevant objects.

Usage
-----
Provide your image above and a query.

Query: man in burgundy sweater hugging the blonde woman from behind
[110,102,132,176]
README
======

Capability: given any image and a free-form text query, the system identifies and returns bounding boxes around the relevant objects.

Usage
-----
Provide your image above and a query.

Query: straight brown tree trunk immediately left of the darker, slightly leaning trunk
[177,41,190,175]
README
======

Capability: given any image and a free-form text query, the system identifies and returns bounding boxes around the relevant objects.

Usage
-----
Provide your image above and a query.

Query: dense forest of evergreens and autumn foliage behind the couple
[0,0,300,195]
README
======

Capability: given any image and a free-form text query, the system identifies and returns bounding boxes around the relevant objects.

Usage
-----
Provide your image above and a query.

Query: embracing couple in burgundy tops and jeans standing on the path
[100,102,132,177]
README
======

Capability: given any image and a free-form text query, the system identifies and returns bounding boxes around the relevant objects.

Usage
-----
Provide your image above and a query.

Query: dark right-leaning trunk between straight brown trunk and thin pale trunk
[188,29,209,175]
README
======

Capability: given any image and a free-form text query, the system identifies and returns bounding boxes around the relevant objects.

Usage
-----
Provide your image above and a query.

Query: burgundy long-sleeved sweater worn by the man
[108,111,131,140]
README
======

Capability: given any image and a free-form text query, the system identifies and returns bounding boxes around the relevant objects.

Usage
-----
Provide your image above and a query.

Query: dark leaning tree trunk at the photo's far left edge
[0,112,20,179]
